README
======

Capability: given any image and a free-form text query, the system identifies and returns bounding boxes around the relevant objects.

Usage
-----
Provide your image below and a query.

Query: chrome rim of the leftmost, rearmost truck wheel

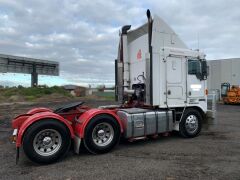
[33,129,62,156]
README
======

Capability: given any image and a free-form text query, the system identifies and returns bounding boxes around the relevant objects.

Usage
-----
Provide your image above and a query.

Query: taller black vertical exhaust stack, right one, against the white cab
[146,9,153,105]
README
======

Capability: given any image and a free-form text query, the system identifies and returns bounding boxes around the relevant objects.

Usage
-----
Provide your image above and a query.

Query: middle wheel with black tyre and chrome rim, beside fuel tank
[83,114,120,154]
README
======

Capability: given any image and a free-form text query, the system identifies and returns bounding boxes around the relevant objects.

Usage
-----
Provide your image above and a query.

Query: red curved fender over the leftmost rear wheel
[16,112,74,147]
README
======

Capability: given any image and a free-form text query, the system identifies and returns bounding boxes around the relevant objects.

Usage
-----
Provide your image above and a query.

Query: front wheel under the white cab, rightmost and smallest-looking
[179,108,203,138]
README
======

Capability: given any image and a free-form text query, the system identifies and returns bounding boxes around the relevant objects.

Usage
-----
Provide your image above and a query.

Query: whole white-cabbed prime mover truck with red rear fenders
[12,10,210,163]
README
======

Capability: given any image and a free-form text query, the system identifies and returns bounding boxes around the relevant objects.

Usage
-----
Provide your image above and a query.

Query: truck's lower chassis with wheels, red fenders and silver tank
[12,102,203,163]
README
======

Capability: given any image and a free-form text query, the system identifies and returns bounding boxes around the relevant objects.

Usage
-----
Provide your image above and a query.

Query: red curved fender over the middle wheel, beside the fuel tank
[75,109,123,138]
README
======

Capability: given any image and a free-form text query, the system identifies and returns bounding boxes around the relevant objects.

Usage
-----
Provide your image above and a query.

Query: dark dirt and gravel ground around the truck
[0,101,240,180]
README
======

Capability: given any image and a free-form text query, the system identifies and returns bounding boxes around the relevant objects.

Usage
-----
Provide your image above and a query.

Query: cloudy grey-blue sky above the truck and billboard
[0,0,240,86]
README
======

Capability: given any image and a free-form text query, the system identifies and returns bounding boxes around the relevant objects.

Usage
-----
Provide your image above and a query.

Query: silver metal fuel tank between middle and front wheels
[117,108,173,138]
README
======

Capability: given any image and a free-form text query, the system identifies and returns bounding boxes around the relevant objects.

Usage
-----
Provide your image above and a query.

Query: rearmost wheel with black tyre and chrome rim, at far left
[23,119,71,164]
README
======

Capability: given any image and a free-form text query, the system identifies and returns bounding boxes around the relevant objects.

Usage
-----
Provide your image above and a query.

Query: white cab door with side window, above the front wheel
[187,59,205,98]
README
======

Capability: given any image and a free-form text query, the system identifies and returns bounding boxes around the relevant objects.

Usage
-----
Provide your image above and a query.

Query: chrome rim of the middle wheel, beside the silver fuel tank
[92,122,114,147]
